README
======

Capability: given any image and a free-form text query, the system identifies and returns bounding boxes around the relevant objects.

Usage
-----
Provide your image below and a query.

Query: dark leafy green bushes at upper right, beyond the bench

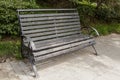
[70,0,120,23]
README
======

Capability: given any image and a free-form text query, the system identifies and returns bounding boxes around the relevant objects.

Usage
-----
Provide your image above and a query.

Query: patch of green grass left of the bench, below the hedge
[0,41,21,59]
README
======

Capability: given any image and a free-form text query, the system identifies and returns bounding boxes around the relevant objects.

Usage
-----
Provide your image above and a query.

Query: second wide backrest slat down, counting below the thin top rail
[20,16,79,22]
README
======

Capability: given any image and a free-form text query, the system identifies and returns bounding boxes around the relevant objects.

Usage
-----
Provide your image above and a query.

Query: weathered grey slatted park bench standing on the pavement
[17,9,99,76]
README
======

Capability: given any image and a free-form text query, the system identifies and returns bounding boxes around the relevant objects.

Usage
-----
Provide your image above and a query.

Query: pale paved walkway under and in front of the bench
[0,34,120,80]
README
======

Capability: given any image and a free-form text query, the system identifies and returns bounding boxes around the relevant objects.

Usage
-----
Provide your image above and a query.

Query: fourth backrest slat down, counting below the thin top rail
[22,22,80,30]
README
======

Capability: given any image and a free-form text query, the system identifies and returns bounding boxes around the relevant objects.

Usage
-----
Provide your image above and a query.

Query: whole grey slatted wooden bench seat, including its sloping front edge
[33,35,95,60]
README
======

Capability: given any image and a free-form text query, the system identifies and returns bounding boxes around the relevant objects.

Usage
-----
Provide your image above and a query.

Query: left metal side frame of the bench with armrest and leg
[17,10,38,77]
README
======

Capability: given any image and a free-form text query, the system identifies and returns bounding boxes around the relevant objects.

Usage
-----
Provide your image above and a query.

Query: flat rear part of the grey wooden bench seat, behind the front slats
[35,34,93,51]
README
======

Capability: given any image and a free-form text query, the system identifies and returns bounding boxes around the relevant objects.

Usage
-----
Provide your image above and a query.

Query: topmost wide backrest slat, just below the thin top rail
[19,12,78,18]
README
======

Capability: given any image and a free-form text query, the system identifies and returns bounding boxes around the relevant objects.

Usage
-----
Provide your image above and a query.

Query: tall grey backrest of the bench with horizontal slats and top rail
[18,9,80,44]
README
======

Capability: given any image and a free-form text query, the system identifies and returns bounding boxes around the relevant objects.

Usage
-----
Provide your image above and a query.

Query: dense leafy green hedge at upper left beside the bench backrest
[0,0,39,37]
